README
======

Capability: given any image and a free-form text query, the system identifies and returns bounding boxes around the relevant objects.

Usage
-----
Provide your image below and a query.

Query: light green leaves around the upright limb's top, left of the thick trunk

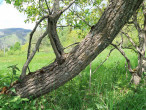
[6,0,107,30]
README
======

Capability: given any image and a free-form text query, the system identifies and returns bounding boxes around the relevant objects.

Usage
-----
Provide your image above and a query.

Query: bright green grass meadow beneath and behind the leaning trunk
[0,49,146,110]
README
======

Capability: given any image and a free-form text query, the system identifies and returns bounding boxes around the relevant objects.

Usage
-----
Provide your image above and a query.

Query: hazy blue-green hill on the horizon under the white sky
[0,28,31,48]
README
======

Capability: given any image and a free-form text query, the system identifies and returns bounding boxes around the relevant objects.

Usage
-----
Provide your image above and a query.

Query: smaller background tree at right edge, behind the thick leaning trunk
[112,2,146,85]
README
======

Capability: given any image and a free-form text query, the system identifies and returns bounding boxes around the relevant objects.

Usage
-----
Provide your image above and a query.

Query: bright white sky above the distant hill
[0,0,35,29]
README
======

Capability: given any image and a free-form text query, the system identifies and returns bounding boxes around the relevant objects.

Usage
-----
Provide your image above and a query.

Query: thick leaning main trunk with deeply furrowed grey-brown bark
[13,0,143,97]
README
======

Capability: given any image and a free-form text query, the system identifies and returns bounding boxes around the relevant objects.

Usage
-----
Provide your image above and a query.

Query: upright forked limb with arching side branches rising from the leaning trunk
[20,0,75,80]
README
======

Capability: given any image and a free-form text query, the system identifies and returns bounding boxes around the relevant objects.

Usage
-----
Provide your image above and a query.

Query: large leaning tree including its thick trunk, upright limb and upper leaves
[4,0,143,97]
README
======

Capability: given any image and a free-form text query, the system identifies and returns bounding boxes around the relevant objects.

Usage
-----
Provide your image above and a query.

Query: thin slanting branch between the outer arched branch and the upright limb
[20,29,48,79]
